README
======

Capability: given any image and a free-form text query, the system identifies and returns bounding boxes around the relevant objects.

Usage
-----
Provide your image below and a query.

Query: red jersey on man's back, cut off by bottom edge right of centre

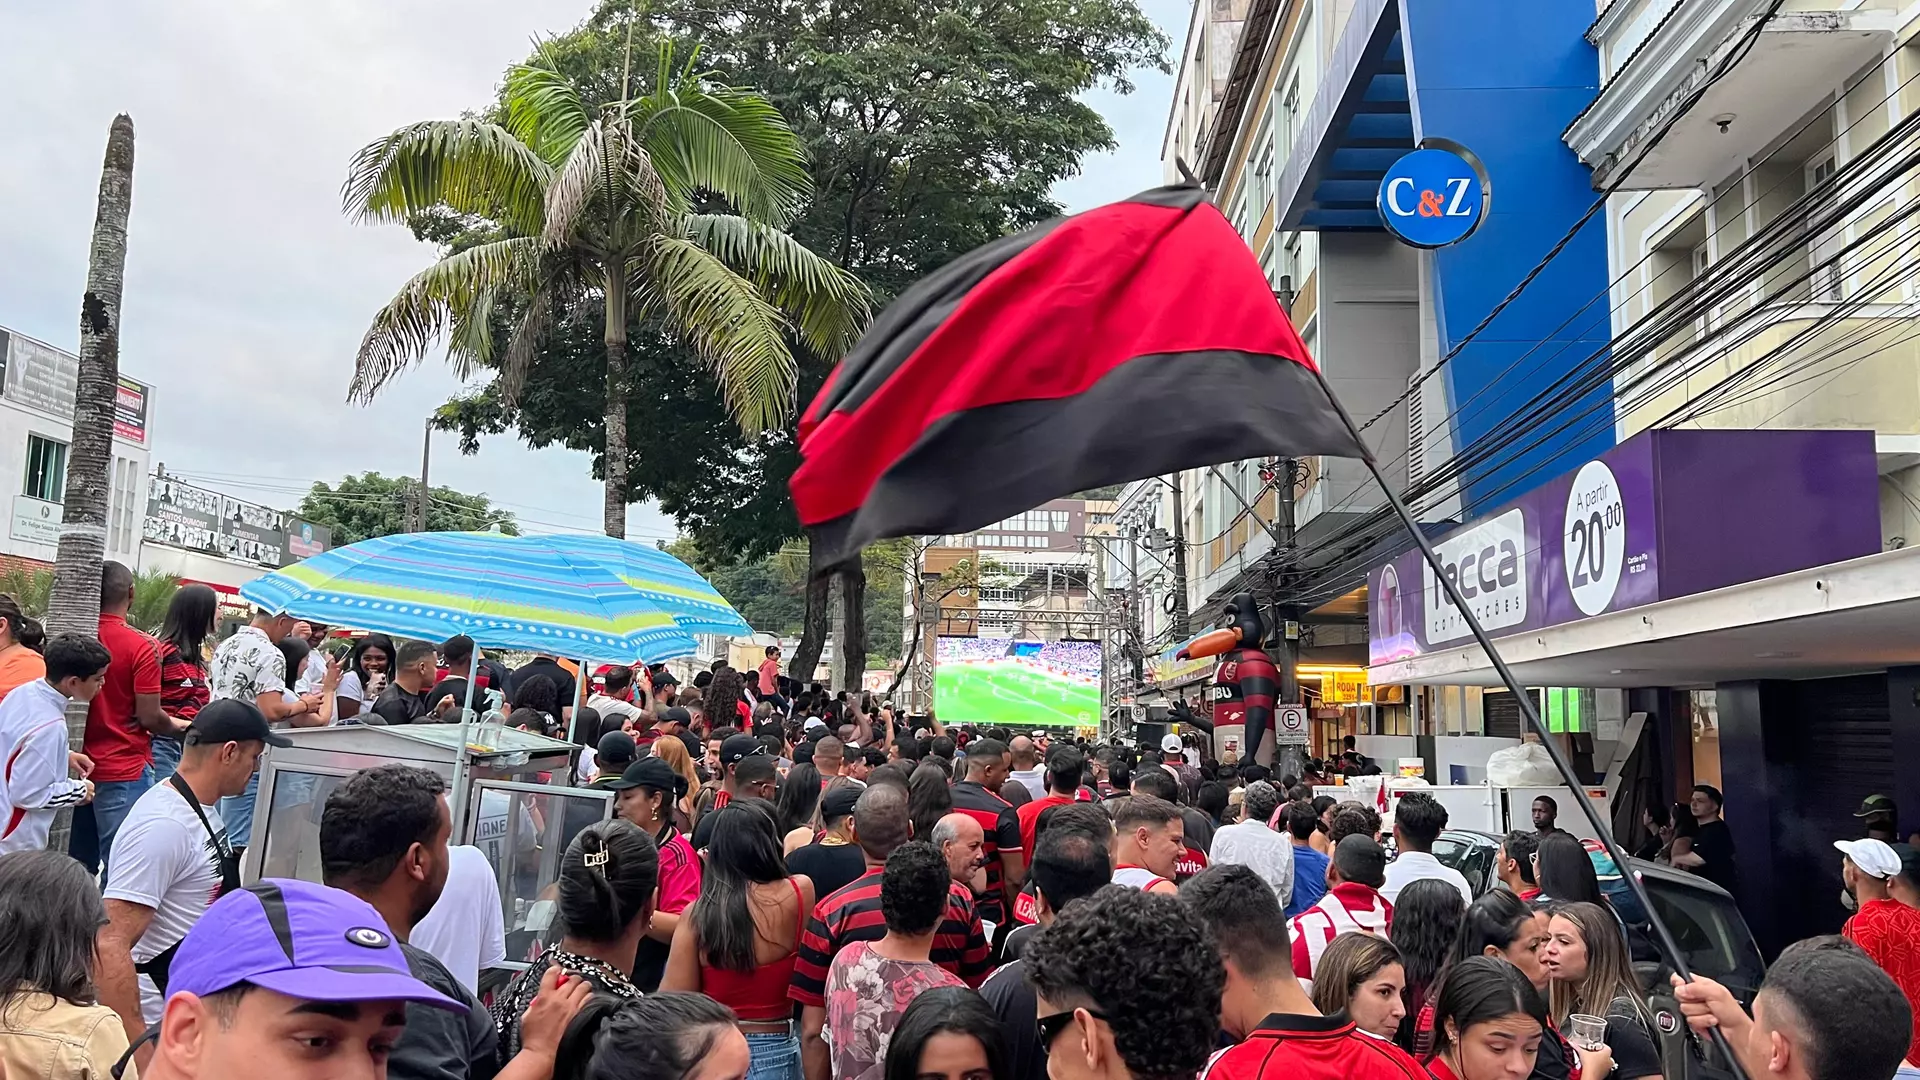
[1200,1013,1430,1080]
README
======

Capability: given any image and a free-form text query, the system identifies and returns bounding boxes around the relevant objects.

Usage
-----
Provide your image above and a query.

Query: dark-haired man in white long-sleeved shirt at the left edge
[0,634,113,853]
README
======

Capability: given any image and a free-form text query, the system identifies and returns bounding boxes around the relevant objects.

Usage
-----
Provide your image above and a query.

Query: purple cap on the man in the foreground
[167,878,467,1013]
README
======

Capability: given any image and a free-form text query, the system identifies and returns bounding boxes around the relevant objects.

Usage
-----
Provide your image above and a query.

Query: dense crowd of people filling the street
[0,563,1920,1080]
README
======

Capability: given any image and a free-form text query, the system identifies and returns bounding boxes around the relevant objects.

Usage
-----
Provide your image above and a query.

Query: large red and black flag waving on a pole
[793,184,1361,565]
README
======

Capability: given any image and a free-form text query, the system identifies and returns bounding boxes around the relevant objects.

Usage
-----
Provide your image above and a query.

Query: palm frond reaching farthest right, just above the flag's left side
[684,213,870,359]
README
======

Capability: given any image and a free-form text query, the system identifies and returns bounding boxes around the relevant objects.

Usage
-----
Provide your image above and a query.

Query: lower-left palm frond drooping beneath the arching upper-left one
[348,236,540,404]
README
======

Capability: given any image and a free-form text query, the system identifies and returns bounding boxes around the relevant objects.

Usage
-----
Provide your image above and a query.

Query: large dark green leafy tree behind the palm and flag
[444,0,1167,675]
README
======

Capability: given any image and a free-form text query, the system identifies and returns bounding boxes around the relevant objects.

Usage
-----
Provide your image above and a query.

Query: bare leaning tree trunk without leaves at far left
[46,113,132,851]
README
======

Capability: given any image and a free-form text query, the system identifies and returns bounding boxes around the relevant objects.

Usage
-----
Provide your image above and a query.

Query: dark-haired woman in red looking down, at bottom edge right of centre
[1425,957,1548,1080]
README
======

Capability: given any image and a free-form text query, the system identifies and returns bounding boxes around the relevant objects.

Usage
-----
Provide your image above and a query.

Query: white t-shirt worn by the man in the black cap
[106,784,227,1024]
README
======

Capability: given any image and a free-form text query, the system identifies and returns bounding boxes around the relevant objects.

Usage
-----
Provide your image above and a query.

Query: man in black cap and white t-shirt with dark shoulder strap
[94,698,292,1042]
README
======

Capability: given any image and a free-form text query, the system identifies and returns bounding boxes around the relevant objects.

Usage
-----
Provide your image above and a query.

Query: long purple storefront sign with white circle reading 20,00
[1374,430,1880,664]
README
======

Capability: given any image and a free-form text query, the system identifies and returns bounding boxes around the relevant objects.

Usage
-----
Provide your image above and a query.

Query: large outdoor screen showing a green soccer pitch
[933,638,1100,728]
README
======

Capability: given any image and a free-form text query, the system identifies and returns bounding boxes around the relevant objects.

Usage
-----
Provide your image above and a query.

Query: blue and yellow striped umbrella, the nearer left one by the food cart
[240,532,697,663]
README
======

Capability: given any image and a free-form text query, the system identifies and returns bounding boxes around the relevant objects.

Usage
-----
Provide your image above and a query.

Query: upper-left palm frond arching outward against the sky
[340,119,553,233]
